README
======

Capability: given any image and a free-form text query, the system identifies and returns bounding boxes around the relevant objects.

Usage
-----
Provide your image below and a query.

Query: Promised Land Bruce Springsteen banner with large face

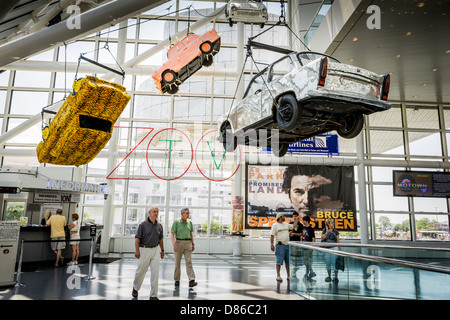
[245,165,357,231]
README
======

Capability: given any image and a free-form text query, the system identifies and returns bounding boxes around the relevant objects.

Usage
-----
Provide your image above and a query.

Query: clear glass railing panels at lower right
[289,242,450,300]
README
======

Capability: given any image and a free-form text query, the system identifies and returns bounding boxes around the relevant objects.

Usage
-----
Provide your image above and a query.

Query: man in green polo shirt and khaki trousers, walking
[171,208,197,287]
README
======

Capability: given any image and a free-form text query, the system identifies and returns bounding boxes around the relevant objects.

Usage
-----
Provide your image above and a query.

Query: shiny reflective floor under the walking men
[0,254,302,300]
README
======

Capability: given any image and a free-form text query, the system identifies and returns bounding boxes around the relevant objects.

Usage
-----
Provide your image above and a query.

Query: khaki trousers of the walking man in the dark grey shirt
[133,246,161,297]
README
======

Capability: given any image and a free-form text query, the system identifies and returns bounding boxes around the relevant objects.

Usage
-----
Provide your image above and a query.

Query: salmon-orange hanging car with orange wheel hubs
[152,29,221,94]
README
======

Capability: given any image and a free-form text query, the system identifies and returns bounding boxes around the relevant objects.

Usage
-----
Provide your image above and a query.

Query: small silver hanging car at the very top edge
[225,0,268,28]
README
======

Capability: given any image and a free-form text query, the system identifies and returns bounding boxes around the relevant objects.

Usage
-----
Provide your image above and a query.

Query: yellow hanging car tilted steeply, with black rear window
[36,76,130,167]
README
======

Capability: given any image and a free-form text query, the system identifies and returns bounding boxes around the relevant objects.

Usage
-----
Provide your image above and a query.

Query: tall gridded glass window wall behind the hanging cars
[0,1,450,245]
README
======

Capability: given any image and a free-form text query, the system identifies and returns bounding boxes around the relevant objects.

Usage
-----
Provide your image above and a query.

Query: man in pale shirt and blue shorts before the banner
[270,212,297,282]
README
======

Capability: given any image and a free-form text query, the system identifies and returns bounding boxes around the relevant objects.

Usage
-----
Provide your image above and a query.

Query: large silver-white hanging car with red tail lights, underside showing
[218,52,391,157]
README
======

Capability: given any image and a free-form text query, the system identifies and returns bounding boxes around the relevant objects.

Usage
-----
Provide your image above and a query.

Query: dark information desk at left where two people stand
[16,225,102,266]
